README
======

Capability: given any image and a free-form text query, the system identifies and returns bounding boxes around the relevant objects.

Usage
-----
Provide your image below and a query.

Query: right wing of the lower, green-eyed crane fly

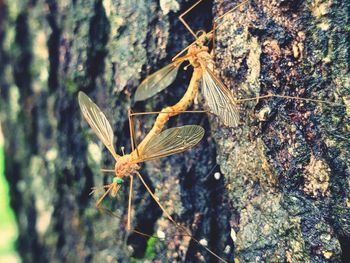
[135,125,204,163]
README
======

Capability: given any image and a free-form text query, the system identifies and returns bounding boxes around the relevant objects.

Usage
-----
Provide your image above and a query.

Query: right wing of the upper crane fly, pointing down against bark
[201,63,239,127]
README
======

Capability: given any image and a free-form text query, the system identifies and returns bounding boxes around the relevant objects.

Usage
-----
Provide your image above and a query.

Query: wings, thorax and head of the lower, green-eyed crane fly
[78,91,204,210]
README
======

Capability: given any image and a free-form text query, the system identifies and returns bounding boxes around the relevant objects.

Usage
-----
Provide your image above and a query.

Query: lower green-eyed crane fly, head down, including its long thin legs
[78,92,226,262]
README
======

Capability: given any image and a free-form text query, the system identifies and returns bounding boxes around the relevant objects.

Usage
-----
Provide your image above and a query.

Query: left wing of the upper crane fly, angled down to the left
[135,58,185,101]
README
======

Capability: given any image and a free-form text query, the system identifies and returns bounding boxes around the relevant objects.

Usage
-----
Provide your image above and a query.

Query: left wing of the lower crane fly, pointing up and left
[78,91,120,160]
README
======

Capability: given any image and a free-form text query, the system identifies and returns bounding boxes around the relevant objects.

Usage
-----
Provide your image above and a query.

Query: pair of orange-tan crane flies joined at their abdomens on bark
[78,0,344,262]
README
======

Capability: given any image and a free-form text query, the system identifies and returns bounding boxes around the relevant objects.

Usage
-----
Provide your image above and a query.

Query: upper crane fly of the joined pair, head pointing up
[134,0,247,127]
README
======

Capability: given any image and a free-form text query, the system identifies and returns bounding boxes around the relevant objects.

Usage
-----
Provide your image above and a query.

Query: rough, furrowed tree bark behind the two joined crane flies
[0,0,350,262]
